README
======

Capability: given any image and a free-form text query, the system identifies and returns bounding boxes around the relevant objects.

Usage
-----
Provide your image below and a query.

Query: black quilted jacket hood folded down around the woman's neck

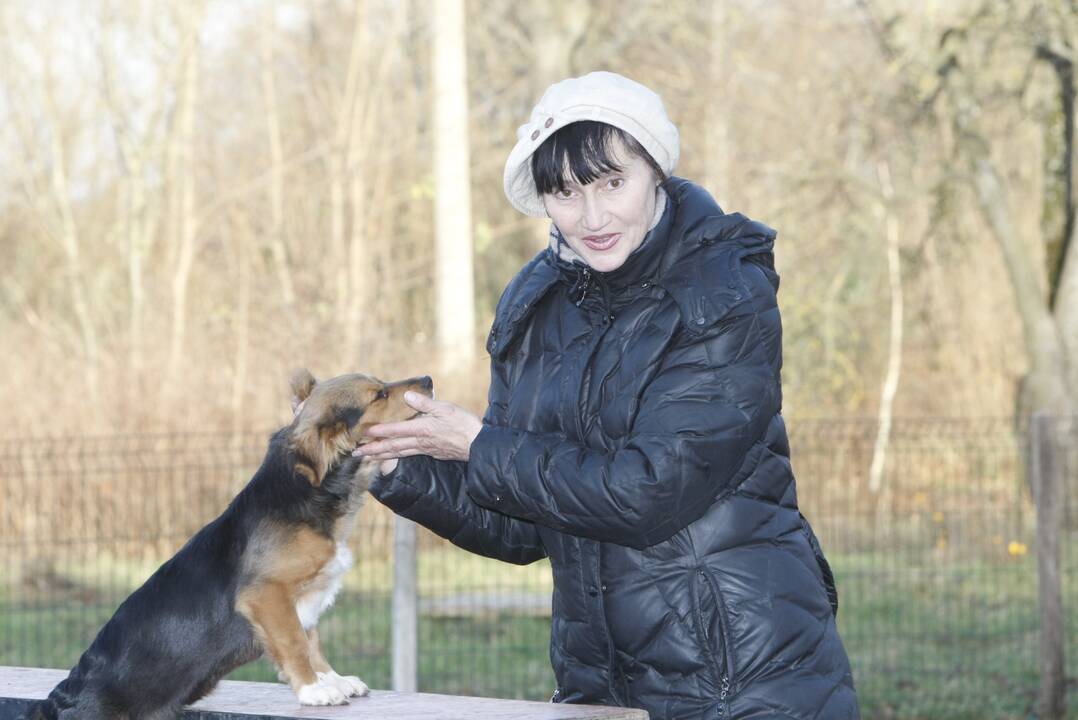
[486,177,776,357]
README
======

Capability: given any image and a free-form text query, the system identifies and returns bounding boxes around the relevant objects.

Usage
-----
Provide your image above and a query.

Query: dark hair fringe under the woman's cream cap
[531,120,666,195]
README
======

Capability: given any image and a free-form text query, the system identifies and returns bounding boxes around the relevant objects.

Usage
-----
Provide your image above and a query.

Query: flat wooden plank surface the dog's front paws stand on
[0,666,648,720]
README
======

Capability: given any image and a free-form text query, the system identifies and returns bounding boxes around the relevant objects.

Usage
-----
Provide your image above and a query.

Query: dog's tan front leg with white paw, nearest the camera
[237,582,348,705]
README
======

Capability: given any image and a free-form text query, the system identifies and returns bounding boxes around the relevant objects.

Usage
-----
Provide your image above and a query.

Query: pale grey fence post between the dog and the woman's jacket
[392,515,418,692]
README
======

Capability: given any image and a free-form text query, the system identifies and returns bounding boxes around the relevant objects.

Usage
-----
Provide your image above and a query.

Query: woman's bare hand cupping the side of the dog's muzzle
[353,392,483,463]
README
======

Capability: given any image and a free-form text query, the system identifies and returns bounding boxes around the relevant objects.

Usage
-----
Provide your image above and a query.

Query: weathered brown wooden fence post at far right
[1029,412,1066,720]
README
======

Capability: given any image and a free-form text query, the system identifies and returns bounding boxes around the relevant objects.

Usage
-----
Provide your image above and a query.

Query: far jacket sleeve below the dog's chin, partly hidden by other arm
[370,357,547,565]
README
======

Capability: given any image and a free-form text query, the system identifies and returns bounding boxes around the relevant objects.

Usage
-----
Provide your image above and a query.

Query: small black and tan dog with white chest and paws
[24,370,432,720]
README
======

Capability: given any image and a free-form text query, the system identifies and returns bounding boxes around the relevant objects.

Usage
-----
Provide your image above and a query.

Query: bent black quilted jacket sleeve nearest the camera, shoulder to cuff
[468,261,780,549]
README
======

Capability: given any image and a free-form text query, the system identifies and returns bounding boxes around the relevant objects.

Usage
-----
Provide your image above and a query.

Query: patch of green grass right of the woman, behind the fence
[837,558,1060,720]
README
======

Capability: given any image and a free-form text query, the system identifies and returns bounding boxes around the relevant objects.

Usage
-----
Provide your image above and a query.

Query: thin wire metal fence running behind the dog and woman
[0,419,1078,719]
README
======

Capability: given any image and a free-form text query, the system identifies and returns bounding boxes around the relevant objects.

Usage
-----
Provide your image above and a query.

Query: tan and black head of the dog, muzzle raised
[291,370,433,486]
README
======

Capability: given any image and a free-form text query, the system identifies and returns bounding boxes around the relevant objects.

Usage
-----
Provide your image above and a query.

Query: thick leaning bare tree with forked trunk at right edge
[862,1,1078,416]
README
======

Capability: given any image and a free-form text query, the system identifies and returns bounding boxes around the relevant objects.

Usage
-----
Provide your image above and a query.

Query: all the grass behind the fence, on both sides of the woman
[0,550,1078,720]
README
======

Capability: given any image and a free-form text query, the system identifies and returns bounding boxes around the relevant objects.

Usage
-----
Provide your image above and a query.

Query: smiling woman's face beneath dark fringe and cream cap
[542,143,658,273]
